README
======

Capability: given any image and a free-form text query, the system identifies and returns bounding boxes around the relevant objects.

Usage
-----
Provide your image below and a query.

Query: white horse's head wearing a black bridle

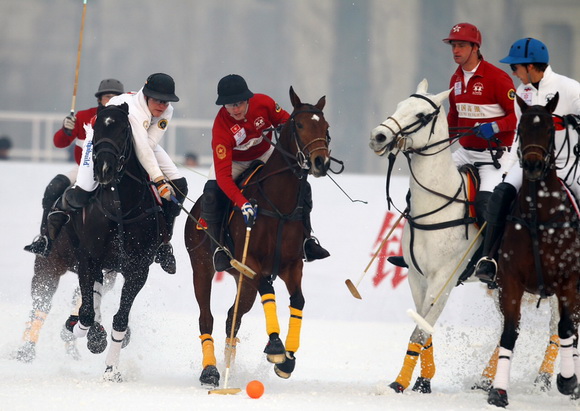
[369,79,451,156]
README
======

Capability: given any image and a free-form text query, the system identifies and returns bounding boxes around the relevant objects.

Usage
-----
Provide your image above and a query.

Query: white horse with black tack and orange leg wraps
[369,80,558,393]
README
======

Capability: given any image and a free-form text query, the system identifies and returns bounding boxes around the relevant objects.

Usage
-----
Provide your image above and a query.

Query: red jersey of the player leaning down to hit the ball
[211,94,290,207]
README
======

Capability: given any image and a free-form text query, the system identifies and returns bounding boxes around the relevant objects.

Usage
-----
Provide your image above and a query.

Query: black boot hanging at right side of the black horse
[155,177,187,274]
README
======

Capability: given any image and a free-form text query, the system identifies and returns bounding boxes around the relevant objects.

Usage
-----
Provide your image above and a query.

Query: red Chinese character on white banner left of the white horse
[371,211,407,289]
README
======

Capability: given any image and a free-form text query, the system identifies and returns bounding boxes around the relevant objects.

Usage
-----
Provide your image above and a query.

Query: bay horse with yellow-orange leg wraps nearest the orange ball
[185,87,331,387]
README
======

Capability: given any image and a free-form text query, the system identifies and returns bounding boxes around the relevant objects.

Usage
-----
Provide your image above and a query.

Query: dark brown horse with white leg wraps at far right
[488,93,580,407]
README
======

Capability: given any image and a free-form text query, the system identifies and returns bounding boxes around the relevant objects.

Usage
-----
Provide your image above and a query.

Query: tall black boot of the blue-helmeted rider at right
[475,183,517,285]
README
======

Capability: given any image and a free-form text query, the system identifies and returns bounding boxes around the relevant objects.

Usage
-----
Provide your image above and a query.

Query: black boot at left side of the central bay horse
[201,180,232,272]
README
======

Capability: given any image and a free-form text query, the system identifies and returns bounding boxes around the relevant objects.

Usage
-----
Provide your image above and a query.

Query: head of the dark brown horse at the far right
[516,93,560,181]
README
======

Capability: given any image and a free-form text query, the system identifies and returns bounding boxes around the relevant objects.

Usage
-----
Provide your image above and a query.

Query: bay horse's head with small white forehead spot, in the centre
[286,87,330,177]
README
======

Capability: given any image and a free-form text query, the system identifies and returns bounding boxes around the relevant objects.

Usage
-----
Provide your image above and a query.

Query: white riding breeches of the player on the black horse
[71,133,182,191]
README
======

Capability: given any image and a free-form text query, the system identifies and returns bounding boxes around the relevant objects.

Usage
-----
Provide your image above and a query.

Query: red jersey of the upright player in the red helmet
[447,60,517,149]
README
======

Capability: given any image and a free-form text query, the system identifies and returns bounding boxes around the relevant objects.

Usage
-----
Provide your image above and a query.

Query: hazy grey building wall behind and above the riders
[0,0,580,173]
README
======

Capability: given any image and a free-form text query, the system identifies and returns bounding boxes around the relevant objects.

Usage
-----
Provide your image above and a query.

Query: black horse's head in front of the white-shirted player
[93,103,133,185]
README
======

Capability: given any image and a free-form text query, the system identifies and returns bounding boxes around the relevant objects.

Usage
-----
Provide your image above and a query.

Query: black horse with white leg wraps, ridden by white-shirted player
[65,103,162,382]
